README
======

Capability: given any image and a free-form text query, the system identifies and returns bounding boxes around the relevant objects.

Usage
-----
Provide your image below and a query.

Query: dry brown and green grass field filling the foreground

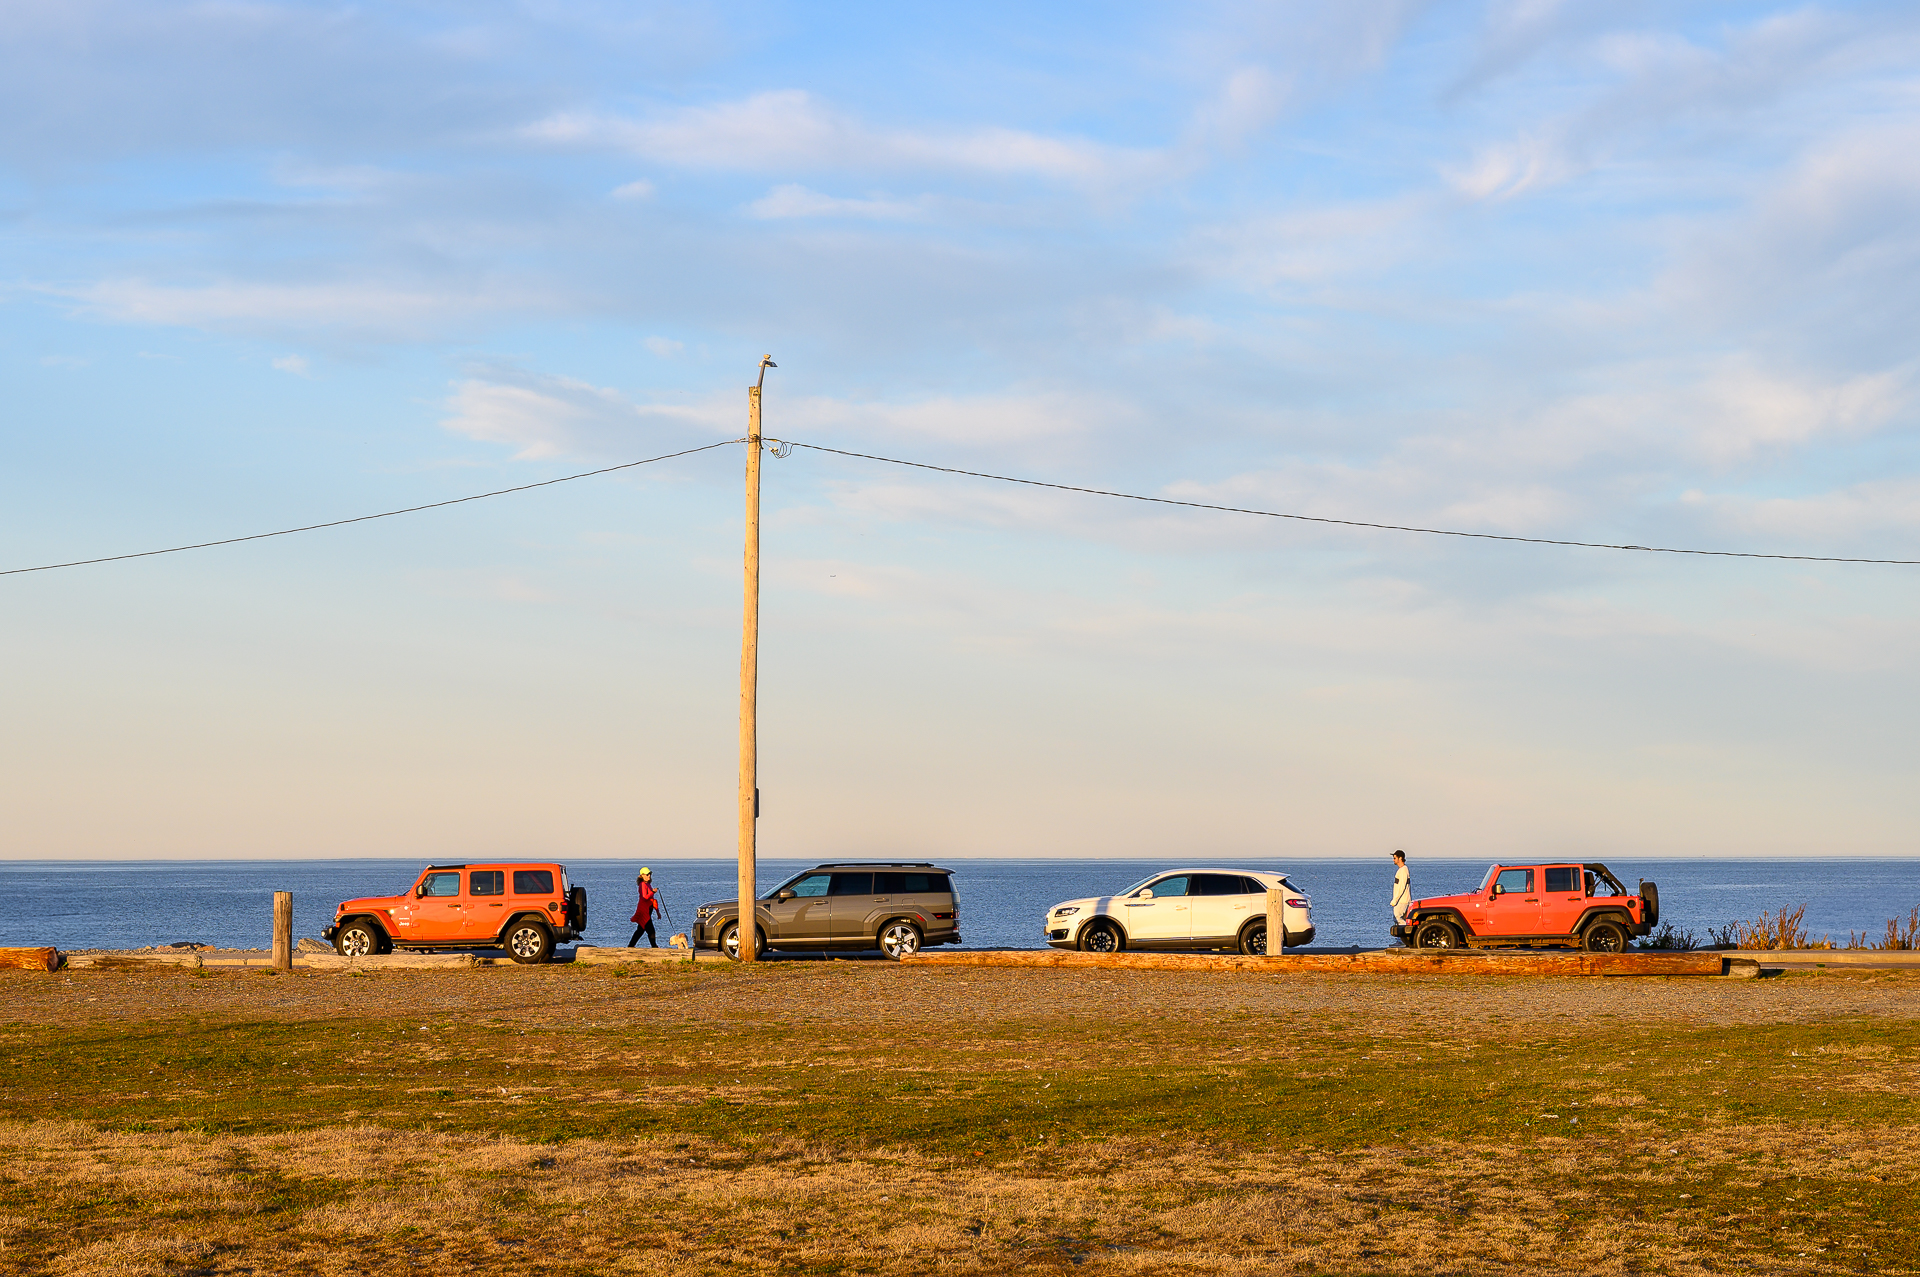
[0,962,1920,1277]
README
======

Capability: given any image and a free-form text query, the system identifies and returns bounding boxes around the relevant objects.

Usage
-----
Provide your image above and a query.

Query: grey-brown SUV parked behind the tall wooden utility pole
[693,860,960,958]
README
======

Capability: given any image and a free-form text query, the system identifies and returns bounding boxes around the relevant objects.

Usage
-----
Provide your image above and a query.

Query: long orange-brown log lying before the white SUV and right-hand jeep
[900,949,1722,976]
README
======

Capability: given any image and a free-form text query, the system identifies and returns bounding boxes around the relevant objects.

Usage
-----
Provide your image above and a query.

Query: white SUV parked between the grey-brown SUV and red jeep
[1043,870,1313,952]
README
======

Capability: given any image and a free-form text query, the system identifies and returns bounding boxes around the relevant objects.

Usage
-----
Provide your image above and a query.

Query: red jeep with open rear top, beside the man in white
[1394,864,1661,952]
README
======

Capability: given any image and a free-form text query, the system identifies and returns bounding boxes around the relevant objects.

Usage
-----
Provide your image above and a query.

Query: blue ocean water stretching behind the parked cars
[0,856,1920,949]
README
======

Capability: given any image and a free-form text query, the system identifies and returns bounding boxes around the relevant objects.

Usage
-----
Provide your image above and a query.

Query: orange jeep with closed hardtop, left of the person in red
[321,864,588,962]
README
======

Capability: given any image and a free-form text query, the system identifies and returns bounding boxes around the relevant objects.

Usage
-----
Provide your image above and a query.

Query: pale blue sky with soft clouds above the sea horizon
[0,0,1920,862]
